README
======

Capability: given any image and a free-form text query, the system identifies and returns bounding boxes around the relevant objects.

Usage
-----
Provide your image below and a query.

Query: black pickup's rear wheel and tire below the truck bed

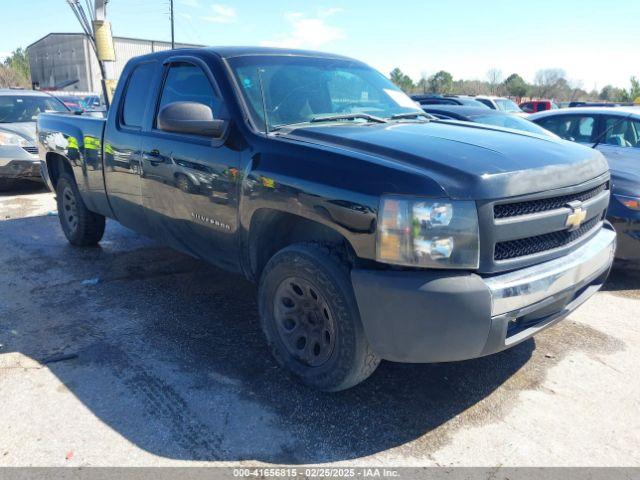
[56,172,105,247]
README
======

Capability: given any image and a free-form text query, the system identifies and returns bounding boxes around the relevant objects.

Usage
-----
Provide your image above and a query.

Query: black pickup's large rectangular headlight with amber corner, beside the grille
[376,196,480,269]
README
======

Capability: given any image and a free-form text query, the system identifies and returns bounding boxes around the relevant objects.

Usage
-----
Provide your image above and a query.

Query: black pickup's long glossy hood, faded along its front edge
[287,121,608,200]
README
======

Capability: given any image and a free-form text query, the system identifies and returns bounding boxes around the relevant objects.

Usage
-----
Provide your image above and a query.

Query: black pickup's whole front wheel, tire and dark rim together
[259,244,380,391]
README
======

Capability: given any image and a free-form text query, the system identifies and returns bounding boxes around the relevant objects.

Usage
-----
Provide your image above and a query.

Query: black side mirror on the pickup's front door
[157,102,225,138]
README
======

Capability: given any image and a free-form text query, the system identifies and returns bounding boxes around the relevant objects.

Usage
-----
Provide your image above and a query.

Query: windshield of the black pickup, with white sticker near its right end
[229,55,422,131]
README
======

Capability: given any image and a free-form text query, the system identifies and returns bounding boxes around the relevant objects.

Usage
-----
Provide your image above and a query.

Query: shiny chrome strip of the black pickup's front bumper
[483,228,616,317]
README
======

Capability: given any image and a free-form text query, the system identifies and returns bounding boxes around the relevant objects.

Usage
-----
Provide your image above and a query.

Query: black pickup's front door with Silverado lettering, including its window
[140,57,240,269]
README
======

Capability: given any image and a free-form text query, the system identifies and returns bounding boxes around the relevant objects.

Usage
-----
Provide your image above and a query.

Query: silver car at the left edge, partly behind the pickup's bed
[0,89,69,189]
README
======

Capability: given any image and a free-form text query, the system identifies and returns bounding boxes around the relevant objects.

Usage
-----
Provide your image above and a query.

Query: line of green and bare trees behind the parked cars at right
[389,68,640,102]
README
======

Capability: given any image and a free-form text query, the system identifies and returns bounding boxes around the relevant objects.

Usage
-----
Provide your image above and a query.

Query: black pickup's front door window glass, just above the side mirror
[158,63,221,125]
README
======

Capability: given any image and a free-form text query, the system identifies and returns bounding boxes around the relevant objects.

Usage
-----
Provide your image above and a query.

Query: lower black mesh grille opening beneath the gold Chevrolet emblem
[493,216,602,260]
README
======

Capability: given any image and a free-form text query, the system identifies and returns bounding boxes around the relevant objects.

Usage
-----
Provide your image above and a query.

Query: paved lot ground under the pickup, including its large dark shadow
[0,189,640,467]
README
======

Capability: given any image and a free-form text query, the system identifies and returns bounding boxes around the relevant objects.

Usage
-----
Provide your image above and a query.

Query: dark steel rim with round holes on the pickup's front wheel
[274,277,336,367]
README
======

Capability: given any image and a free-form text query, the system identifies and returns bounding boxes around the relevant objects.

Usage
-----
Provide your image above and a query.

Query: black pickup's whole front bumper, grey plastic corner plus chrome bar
[351,223,616,363]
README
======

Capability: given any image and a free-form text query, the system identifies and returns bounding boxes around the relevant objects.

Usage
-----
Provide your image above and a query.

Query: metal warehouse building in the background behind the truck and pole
[27,33,202,93]
